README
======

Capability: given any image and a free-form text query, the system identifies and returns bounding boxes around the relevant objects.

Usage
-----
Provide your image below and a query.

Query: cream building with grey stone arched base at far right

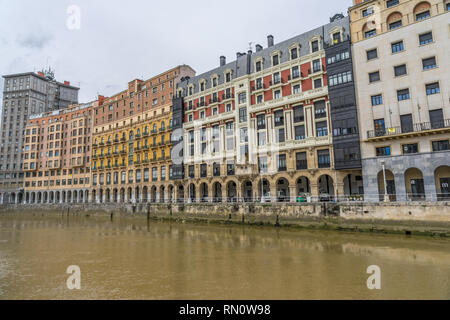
[349,0,450,201]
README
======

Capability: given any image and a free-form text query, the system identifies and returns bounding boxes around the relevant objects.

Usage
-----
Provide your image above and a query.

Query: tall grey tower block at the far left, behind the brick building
[0,70,79,203]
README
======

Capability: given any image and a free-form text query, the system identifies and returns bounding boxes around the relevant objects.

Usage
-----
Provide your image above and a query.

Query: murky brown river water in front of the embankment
[0,215,450,300]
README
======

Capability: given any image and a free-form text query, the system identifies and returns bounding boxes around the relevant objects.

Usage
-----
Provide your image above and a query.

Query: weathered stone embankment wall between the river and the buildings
[0,202,450,237]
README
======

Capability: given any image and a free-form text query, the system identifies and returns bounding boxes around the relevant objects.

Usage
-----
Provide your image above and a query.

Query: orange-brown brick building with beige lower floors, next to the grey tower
[23,102,97,204]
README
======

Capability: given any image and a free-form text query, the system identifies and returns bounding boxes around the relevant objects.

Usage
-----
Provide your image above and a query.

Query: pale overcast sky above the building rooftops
[0,0,352,102]
